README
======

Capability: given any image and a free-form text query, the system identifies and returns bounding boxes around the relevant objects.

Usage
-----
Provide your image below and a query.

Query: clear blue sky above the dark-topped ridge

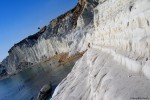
[0,0,78,61]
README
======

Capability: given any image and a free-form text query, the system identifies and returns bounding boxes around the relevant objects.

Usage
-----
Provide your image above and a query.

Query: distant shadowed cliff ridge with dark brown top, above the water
[0,0,96,75]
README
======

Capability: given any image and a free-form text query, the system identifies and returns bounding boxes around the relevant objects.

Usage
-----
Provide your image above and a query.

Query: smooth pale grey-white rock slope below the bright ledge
[51,49,150,100]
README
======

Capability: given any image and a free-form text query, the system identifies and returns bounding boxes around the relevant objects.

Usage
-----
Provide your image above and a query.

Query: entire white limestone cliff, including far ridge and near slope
[2,0,150,100]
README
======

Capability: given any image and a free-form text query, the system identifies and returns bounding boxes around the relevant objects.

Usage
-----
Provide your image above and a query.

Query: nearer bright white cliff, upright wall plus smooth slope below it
[52,0,150,100]
